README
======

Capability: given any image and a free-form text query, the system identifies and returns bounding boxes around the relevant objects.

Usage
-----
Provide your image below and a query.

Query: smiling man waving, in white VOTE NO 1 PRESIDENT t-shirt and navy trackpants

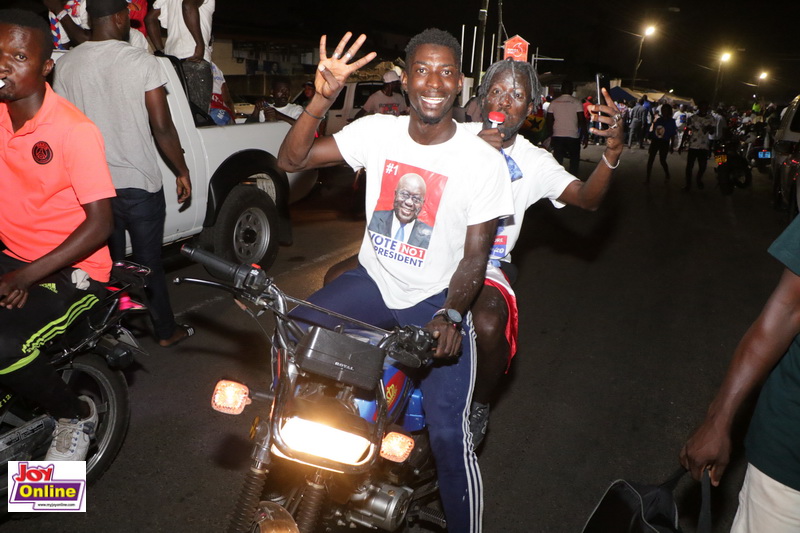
[278,29,513,532]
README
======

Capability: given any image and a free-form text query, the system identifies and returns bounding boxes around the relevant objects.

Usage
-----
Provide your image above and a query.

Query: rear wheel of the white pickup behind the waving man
[211,185,278,270]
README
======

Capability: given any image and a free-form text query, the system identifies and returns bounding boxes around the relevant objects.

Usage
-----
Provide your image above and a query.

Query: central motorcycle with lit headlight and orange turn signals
[175,246,446,533]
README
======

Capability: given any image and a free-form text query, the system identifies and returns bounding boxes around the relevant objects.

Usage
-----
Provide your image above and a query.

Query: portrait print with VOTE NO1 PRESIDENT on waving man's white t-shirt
[367,160,447,268]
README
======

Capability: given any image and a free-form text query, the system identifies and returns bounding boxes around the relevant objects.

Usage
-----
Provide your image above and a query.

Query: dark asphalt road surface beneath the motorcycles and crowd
[0,146,784,533]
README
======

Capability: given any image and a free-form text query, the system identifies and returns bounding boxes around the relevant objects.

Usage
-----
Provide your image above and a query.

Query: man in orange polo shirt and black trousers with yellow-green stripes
[0,9,114,461]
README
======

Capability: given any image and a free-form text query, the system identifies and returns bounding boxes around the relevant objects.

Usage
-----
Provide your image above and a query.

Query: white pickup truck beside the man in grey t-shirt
[53,51,317,269]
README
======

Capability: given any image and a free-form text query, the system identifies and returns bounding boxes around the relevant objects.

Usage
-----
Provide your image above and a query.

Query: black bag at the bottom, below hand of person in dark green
[583,468,711,533]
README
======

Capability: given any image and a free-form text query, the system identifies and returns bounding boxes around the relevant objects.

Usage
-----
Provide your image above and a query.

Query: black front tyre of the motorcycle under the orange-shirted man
[57,354,131,483]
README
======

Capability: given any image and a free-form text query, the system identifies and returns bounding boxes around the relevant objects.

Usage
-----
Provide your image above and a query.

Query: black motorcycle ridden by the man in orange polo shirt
[0,262,150,493]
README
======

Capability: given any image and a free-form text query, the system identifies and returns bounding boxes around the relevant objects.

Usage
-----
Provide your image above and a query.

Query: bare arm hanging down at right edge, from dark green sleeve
[680,270,800,485]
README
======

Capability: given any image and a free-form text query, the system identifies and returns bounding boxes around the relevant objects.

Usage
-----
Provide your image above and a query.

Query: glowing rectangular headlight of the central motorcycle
[281,416,370,465]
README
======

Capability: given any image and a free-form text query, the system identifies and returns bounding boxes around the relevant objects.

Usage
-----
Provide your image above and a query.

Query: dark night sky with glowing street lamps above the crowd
[216,0,800,103]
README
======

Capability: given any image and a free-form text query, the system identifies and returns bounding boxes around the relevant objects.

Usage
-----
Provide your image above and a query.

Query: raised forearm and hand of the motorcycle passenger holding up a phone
[558,89,625,211]
